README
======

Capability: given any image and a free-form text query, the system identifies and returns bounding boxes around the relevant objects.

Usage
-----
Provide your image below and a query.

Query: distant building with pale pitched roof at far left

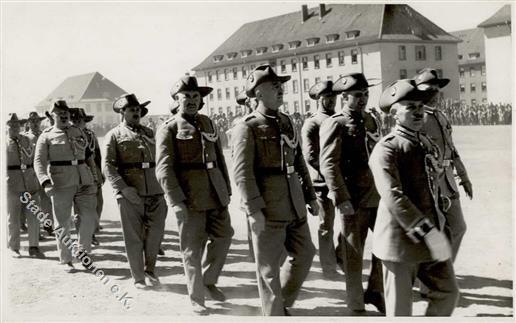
[36,72,126,124]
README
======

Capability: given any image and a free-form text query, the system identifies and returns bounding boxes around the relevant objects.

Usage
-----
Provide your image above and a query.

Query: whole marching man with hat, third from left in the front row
[102,94,167,289]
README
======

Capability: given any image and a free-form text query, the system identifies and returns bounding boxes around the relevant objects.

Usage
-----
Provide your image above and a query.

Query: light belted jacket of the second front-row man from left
[34,126,96,188]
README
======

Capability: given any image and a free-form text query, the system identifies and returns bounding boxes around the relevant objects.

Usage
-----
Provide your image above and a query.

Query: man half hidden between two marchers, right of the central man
[301,81,342,279]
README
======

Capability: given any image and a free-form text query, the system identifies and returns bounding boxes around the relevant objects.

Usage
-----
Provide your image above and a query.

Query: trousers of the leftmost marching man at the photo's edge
[7,189,39,250]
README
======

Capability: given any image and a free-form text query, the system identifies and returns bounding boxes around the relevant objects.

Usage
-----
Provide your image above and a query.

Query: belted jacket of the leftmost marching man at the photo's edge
[6,134,41,192]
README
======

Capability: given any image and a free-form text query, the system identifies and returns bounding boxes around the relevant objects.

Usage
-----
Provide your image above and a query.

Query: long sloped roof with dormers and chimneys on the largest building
[193,4,459,71]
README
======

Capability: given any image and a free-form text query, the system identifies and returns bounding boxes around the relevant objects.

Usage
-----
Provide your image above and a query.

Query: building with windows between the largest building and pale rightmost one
[451,28,487,105]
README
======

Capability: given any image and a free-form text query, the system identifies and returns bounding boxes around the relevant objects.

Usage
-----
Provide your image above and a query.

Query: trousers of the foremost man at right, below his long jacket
[382,260,459,317]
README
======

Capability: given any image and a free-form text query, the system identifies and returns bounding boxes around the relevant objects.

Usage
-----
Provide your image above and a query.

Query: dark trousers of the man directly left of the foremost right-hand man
[337,208,383,311]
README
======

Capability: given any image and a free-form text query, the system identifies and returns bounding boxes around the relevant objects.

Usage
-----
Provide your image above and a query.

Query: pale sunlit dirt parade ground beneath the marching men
[1,126,514,321]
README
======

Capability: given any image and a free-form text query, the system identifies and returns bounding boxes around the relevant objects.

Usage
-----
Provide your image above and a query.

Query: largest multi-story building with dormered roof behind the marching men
[193,4,459,114]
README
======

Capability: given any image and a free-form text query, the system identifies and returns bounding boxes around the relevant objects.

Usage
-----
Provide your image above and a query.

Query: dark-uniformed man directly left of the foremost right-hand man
[320,73,385,315]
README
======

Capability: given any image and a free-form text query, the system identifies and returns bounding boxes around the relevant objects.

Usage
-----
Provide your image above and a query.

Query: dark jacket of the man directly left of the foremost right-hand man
[320,108,380,209]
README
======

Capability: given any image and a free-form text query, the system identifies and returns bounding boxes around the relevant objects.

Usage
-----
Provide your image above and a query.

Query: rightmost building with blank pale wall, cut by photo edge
[478,4,514,104]
